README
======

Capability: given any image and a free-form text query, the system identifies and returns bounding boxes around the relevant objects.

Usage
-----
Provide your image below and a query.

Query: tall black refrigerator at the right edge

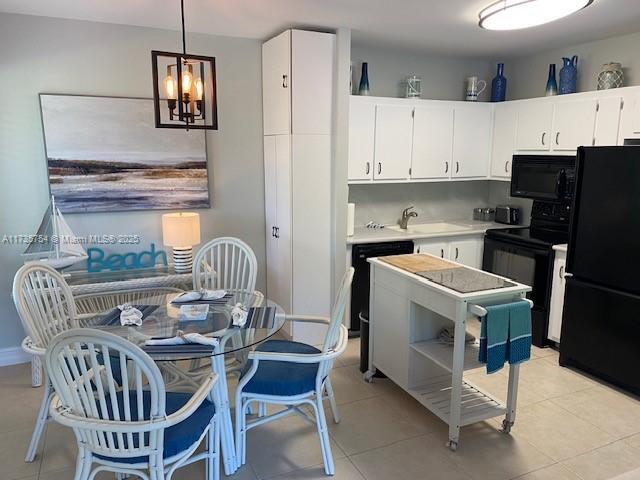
[560,146,640,394]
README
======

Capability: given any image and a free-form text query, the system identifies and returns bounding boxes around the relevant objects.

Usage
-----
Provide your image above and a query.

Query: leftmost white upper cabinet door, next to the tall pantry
[348,98,376,180]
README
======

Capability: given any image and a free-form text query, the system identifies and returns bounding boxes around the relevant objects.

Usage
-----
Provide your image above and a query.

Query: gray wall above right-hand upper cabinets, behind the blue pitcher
[505,29,640,100]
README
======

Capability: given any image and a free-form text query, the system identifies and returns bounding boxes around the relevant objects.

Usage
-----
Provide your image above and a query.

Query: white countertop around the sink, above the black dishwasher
[347,219,512,245]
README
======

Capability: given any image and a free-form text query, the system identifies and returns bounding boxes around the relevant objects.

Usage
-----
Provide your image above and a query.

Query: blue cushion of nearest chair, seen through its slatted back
[96,391,215,463]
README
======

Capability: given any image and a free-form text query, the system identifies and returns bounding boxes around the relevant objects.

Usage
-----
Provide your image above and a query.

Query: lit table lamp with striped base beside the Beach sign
[162,212,200,273]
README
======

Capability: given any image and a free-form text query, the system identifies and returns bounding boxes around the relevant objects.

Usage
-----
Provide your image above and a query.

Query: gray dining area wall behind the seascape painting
[0,13,265,348]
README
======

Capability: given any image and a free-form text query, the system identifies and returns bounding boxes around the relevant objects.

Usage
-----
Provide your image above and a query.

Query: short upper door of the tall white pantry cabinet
[262,30,291,135]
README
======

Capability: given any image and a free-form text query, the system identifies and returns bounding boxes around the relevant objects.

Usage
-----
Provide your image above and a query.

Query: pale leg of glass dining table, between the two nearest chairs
[211,351,238,475]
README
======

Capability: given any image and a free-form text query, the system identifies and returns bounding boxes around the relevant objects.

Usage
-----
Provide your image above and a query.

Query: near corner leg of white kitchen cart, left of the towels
[449,302,467,451]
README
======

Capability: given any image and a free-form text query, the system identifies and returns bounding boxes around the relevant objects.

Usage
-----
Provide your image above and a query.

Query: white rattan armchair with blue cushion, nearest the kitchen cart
[236,268,354,475]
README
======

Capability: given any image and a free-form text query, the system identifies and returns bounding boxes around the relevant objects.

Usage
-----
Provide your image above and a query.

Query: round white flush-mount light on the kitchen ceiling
[478,0,594,30]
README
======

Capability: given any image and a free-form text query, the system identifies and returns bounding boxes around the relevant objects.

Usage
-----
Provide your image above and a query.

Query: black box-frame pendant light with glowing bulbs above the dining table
[151,0,218,130]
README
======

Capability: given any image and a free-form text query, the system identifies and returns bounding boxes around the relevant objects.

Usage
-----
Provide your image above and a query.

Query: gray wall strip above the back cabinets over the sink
[351,43,493,100]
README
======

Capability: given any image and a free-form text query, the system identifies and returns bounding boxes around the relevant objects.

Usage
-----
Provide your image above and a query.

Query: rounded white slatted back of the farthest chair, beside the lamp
[193,237,258,292]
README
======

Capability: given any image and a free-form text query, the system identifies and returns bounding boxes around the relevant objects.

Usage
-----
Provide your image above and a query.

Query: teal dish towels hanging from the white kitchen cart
[478,300,531,373]
